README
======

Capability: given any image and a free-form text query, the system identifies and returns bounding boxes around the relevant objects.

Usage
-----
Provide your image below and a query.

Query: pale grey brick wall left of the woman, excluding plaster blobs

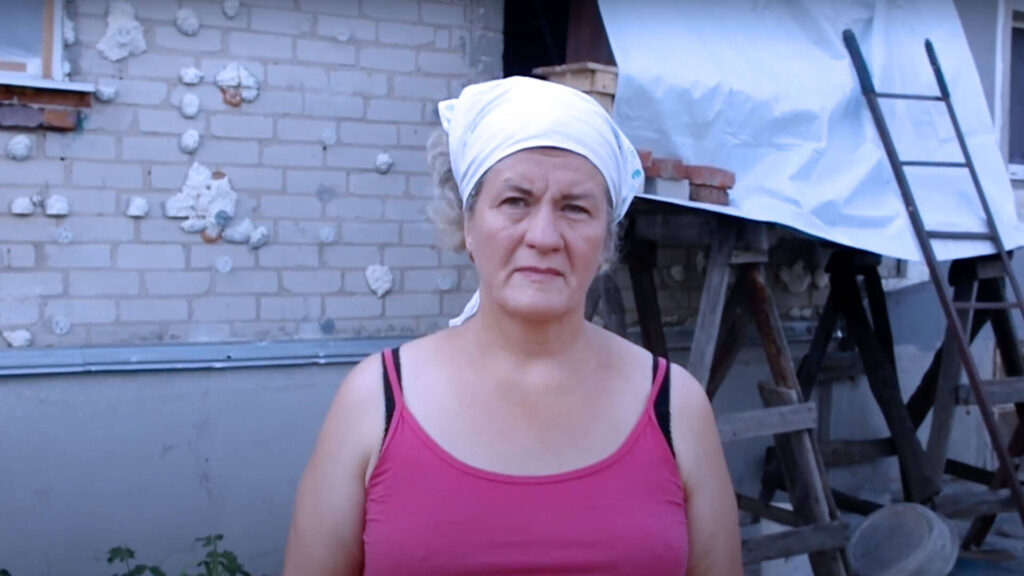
[0,0,503,346]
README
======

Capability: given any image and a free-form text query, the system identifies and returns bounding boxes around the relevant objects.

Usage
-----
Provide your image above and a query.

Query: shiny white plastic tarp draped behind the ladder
[600,0,1024,259]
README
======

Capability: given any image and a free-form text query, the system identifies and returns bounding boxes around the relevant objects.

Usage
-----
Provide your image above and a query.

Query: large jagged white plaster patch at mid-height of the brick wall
[164,162,239,233]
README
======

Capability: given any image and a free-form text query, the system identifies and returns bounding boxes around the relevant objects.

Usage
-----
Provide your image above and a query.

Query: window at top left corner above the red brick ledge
[0,0,65,85]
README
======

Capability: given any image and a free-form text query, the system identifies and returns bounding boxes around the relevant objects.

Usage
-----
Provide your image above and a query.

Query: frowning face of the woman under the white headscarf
[465,148,609,321]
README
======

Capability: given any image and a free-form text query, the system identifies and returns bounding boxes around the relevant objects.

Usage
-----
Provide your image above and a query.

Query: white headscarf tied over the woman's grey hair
[437,76,644,326]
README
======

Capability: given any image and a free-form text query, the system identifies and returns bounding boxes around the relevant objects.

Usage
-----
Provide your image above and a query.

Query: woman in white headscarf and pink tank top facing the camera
[285,78,742,576]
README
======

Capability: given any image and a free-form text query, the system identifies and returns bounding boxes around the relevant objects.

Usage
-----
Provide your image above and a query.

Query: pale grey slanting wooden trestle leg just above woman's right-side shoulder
[686,220,736,386]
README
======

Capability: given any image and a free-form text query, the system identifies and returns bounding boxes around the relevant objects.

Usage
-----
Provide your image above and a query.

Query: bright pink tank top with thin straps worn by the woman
[362,351,688,576]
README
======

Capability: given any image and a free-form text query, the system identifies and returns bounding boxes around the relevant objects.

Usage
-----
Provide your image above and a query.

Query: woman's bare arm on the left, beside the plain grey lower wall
[283,355,384,576]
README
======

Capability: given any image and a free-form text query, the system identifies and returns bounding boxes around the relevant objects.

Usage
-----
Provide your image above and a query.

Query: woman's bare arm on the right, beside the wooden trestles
[671,364,743,576]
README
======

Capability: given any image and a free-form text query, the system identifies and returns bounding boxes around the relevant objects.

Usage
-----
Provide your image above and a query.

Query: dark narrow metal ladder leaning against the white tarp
[843,30,1024,523]
